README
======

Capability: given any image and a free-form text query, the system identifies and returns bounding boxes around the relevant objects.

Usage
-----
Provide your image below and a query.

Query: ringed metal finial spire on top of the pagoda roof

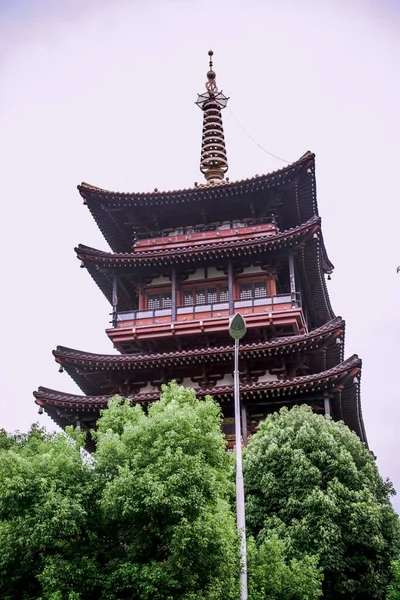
[196,50,228,183]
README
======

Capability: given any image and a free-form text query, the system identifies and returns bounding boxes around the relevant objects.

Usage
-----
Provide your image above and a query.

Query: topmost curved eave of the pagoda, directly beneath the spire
[78,152,318,252]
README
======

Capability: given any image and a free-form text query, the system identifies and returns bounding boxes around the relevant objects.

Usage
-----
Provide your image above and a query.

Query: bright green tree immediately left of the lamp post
[92,383,238,600]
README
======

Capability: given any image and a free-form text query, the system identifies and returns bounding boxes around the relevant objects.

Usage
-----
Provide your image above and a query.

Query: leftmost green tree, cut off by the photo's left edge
[0,426,94,600]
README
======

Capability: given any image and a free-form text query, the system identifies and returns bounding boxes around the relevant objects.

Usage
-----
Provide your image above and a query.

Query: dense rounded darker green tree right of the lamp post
[243,406,400,600]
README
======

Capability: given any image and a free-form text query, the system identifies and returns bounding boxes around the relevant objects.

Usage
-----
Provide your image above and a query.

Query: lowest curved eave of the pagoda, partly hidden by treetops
[34,355,366,442]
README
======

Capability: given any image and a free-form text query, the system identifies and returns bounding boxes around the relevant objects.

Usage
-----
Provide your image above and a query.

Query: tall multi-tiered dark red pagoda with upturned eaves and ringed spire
[34,51,366,445]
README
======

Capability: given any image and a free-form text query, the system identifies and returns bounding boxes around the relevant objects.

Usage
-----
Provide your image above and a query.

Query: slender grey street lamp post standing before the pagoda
[229,313,247,600]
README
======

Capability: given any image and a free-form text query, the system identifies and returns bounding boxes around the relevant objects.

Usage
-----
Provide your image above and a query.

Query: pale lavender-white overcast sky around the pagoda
[0,0,400,510]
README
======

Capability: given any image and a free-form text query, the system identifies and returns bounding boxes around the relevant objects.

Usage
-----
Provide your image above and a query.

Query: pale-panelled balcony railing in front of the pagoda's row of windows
[113,292,301,327]
